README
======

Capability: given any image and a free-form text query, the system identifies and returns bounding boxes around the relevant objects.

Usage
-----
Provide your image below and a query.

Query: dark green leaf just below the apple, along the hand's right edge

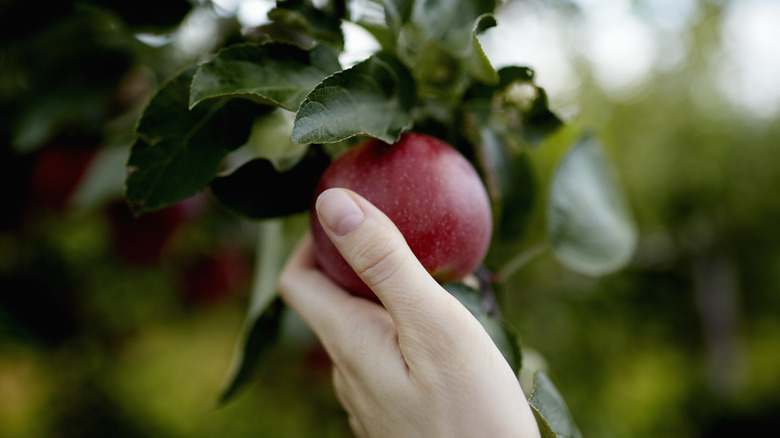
[444,283,522,374]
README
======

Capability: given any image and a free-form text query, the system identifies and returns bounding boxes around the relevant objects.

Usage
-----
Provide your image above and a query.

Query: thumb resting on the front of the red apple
[316,189,468,334]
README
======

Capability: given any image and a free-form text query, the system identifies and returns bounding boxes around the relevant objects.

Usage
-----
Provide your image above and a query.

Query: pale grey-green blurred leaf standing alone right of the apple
[547,135,637,275]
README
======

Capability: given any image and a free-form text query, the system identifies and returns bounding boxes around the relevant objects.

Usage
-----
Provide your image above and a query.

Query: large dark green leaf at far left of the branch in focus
[125,67,271,214]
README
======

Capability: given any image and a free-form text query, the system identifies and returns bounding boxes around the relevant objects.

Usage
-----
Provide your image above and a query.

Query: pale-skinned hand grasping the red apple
[280,189,539,438]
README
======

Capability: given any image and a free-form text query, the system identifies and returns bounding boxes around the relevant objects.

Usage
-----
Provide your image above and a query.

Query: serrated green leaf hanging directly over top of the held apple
[291,52,415,143]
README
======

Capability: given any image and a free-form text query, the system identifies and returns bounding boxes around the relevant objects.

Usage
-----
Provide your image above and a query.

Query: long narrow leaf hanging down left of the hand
[219,214,309,404]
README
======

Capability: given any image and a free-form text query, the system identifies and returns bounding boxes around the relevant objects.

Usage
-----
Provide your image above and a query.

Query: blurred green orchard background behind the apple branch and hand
[0,0,780,438]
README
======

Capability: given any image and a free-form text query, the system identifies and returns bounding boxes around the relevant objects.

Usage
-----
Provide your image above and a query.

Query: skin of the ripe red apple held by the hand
[311,133,493,301]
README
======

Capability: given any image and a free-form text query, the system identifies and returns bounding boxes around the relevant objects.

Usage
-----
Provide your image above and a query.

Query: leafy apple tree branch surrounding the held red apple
[125,0,636,437]
